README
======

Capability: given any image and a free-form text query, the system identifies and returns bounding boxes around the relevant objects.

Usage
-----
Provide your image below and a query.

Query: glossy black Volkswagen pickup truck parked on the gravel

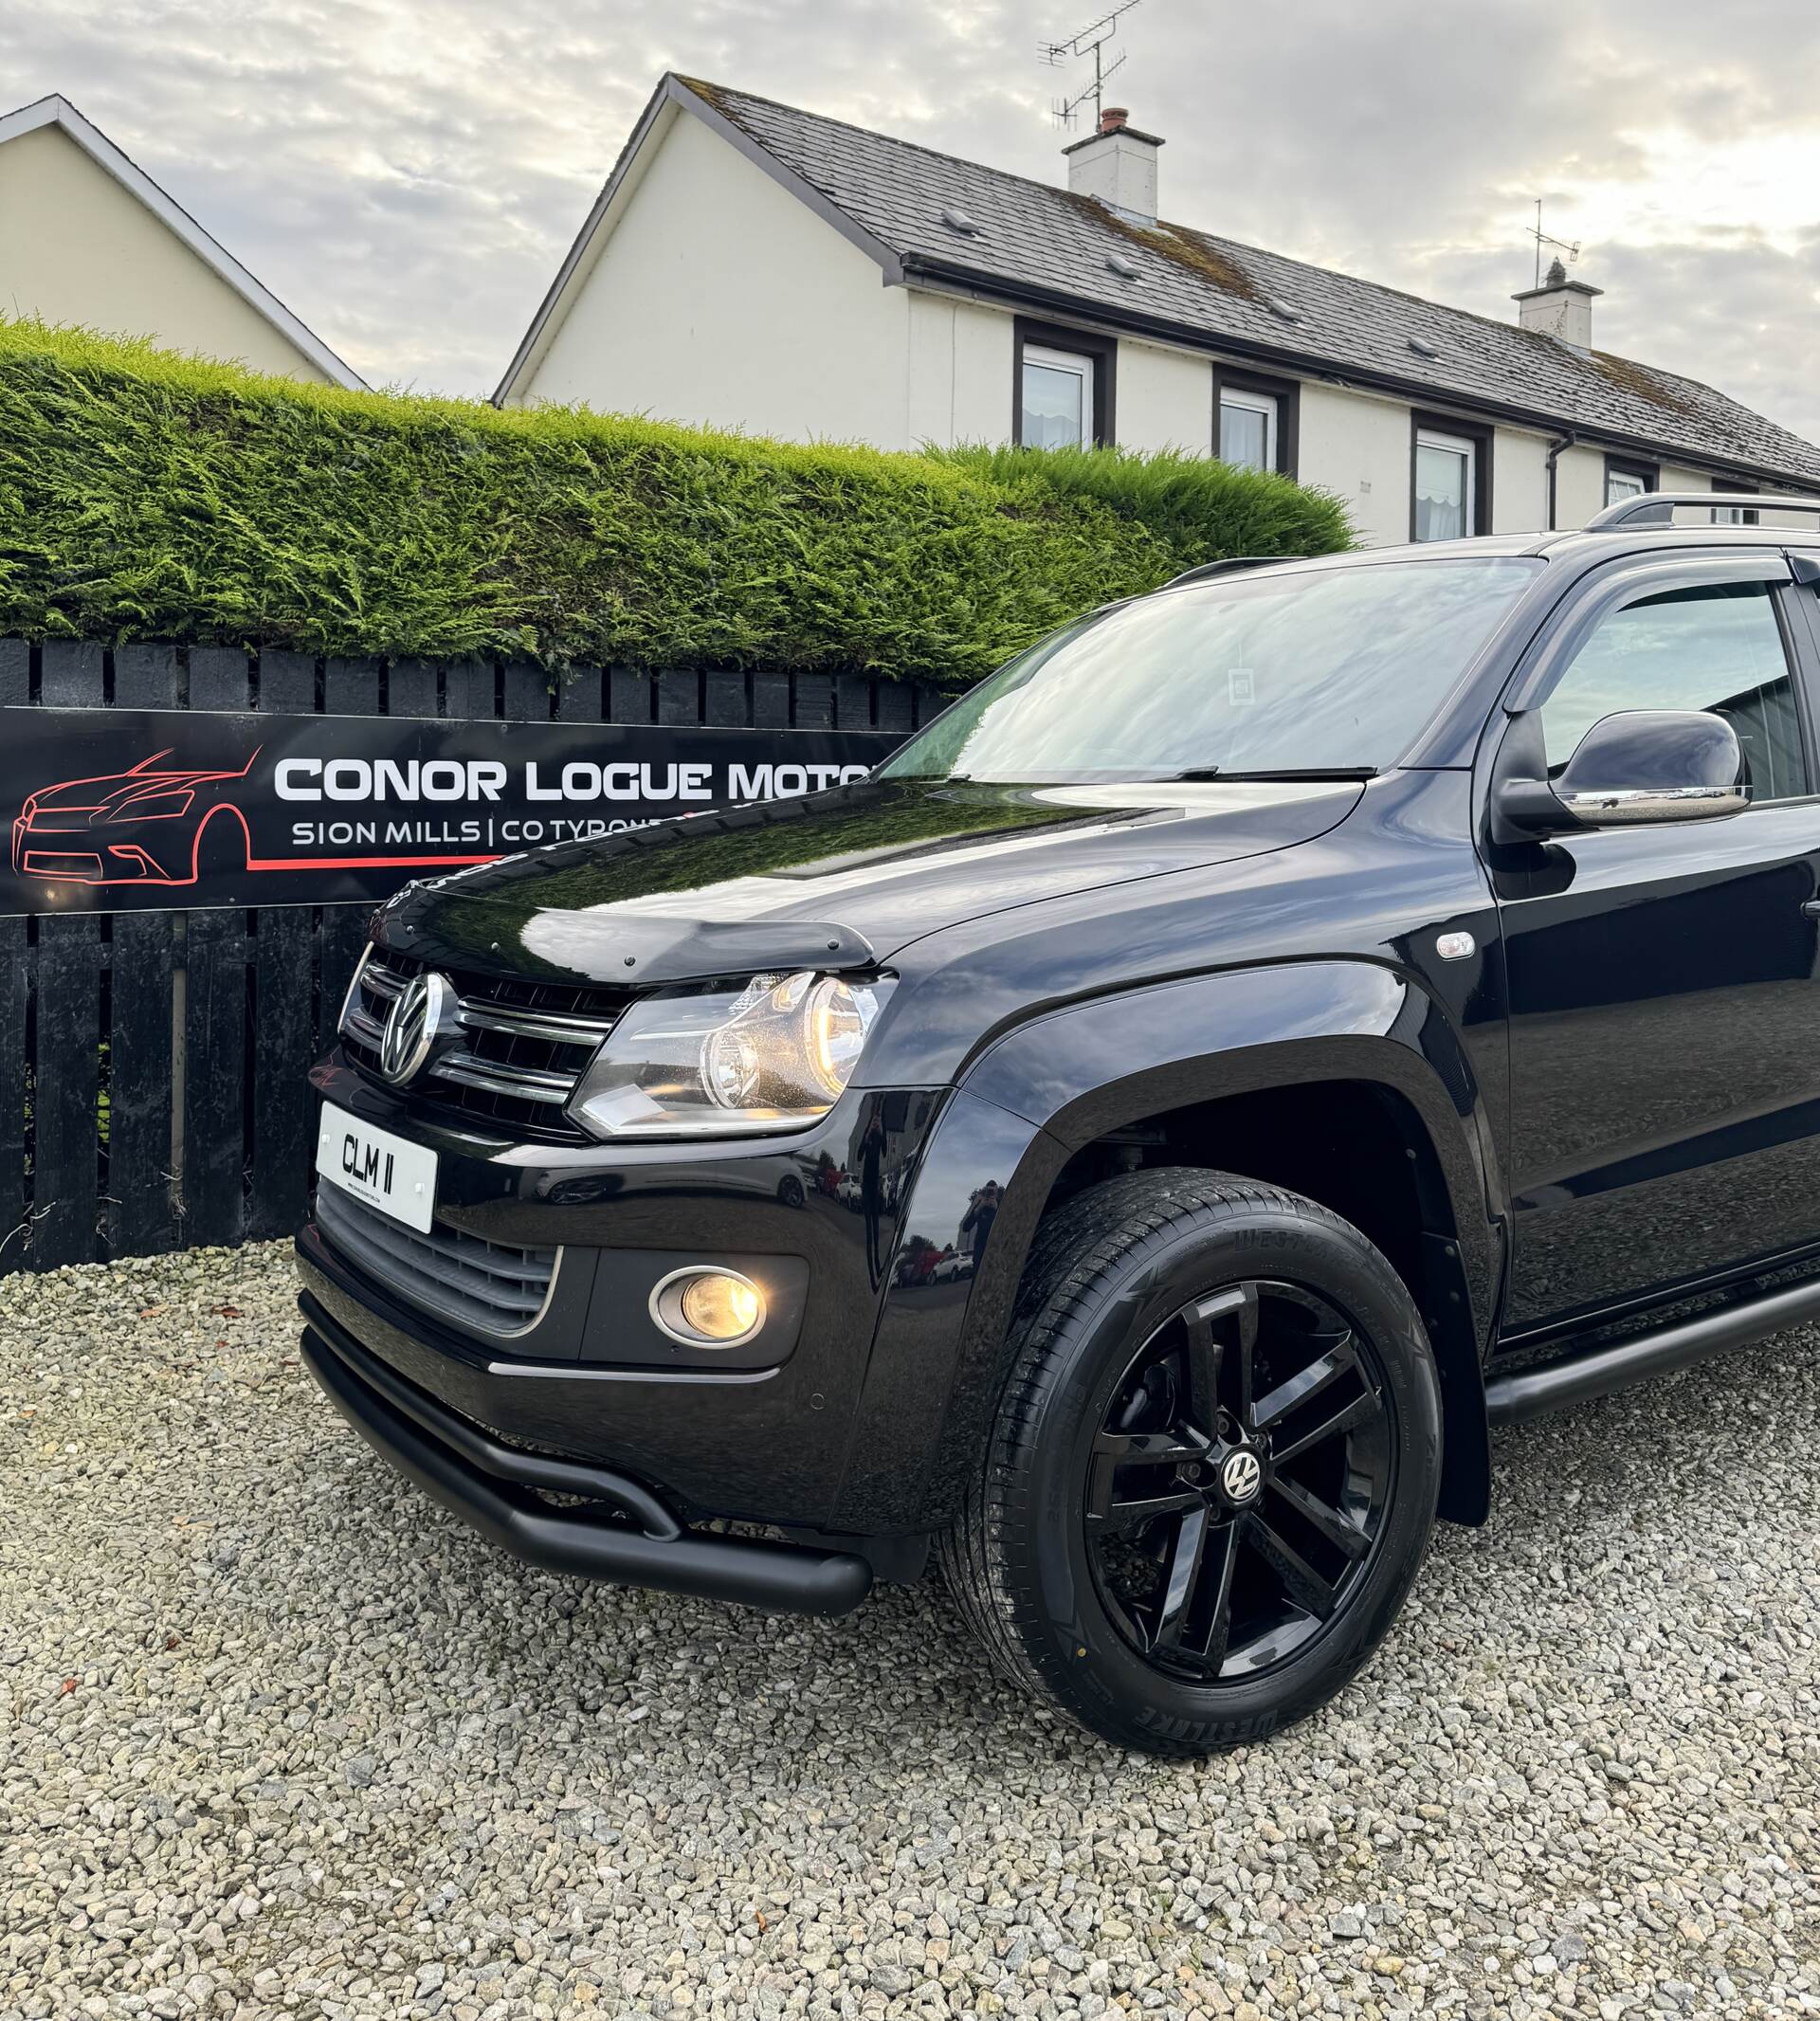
[299,495,1820,1755]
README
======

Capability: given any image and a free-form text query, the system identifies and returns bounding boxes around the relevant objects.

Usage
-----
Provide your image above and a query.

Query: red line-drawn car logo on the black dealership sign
[12,746,263,885]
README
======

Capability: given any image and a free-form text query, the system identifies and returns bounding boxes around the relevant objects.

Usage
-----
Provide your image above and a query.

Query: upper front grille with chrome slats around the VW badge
[341,948,630,1144]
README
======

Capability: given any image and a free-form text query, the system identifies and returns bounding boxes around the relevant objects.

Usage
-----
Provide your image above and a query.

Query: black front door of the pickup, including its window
[1491,555,1820,1330]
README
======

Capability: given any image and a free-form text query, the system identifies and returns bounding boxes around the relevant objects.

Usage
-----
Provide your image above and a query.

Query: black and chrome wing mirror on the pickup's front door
[1495,709,1752,841]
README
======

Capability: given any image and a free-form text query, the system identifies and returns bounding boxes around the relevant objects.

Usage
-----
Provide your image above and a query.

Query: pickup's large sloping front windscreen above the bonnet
[879,555,1545,786]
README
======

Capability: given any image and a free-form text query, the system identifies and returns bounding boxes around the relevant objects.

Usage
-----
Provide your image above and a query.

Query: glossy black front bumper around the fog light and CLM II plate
[297,1057,947,1540]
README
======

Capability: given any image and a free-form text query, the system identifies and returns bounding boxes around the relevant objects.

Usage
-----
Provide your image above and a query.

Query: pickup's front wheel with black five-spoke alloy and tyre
[941,1170,1440,1757]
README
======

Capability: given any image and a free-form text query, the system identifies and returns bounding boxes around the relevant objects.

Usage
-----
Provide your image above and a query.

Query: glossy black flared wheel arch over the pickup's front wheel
[843,960,1502,1528]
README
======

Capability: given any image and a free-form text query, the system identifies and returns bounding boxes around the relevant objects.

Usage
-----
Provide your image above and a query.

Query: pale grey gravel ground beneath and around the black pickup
[0,1247,1820,2021]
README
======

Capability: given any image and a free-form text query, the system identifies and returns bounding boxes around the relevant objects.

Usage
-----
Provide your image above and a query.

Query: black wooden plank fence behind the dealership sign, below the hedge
[0,639,943,1273]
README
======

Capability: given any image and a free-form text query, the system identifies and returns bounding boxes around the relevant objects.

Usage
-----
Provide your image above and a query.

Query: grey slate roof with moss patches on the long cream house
[679,79,1820,487]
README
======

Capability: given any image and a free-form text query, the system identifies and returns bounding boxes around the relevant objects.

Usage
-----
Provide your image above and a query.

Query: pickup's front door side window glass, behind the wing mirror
[1541,582,1810,800]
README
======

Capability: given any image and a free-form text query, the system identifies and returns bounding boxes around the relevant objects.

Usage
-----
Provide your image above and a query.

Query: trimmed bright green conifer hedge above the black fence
[0,321,1352,687]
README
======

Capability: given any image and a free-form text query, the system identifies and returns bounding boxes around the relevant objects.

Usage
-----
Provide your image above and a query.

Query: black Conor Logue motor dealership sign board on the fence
[0,707,899,914]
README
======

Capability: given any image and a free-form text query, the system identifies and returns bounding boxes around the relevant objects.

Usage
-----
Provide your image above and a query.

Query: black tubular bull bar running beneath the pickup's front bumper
[303,1291,873,1614]
